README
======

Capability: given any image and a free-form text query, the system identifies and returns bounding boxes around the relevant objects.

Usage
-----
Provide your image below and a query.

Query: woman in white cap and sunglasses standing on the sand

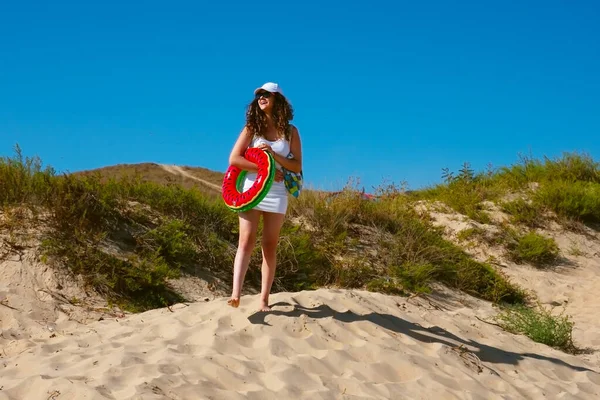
[227,82,302,311]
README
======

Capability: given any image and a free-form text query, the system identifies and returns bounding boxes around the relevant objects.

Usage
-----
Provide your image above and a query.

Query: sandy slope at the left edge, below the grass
[0,247,117,362]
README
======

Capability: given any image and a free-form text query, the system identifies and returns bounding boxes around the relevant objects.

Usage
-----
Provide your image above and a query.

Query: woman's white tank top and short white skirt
[243,137,290,214]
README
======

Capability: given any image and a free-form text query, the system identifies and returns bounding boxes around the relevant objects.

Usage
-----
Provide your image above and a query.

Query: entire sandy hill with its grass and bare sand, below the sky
[0,152,600,400]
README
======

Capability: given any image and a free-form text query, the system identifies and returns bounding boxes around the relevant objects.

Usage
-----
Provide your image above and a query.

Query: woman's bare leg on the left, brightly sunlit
[227,210,261,307]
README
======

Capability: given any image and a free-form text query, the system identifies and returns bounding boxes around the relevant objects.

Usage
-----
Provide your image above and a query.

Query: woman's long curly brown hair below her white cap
[246,93,294,140]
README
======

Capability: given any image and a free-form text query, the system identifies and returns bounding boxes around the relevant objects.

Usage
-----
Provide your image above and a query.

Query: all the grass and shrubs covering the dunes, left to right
[0,147,600,354]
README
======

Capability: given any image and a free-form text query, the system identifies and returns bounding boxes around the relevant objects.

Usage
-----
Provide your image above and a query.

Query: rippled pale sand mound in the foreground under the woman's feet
[0,289,600,400]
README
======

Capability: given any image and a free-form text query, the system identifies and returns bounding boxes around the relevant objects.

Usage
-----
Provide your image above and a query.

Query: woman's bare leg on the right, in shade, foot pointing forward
[259,212,285,311]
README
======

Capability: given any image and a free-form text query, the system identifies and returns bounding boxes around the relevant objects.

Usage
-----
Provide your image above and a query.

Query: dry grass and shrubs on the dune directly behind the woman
[0,145,523,309]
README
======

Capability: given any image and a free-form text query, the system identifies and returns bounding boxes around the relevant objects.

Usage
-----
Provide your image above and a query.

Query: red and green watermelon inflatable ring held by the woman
[221,147,275,212]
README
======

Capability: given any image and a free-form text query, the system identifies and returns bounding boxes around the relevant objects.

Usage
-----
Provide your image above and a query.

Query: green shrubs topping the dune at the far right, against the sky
[418,153,600,226]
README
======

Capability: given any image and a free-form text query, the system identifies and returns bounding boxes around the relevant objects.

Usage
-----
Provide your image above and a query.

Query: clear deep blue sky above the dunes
[0,0,600,191]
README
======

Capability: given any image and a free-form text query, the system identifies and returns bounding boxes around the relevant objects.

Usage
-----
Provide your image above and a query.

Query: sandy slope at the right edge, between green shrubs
[431,202,600,364]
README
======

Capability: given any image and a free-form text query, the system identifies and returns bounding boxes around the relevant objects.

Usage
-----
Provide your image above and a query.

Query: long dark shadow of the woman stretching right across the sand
[248,302,600,374]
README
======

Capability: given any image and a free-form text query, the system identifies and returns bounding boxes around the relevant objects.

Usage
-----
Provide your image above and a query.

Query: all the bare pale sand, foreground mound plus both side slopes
[0,205,600,400]
